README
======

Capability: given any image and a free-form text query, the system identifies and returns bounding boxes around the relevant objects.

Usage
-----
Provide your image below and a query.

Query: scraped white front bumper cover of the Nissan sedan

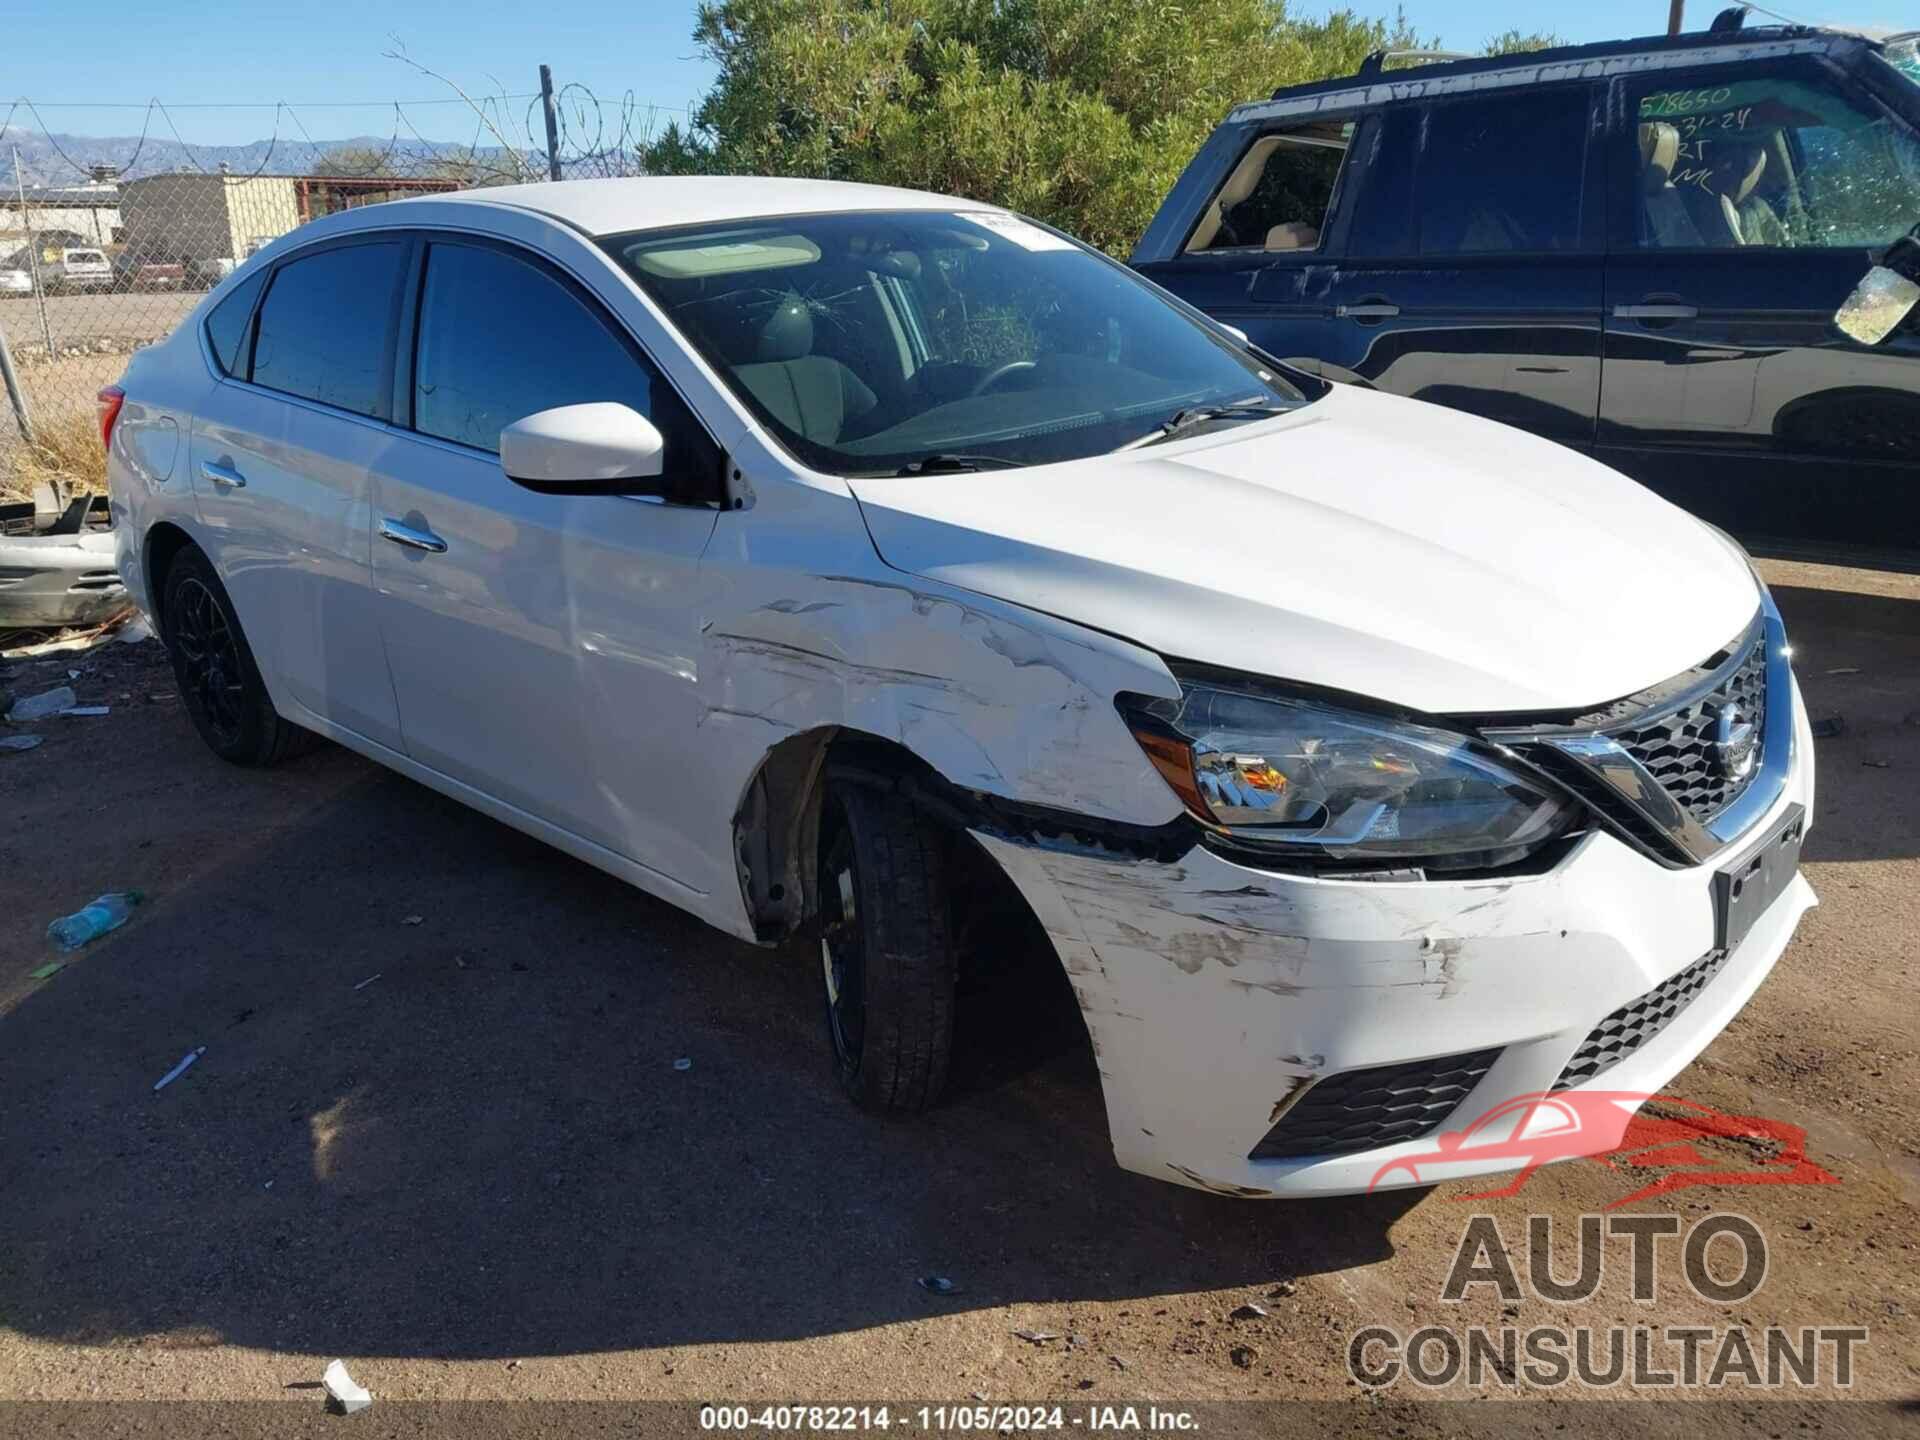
[979,703,1816,1196]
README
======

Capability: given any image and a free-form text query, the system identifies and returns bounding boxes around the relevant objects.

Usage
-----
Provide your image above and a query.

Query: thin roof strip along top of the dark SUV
[1225,25,1880,125]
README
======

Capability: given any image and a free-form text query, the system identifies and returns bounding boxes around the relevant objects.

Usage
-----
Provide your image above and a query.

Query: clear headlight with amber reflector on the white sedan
[1121,682,1574,870]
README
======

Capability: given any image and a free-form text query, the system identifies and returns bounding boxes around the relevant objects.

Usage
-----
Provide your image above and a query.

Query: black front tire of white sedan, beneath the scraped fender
[818,783,958,1114]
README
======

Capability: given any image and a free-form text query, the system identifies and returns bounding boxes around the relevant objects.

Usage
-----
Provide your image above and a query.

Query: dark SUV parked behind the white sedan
[1131,13,1920,566]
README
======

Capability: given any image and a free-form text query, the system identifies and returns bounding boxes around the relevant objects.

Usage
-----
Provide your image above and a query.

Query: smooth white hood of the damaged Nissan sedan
[852,386,1759,714]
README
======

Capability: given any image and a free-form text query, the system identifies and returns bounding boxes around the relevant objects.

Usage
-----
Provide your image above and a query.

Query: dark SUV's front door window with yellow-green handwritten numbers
[1630,69,1920,250]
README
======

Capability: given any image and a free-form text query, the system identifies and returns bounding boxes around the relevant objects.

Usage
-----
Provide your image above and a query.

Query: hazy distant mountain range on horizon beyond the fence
[0,125,541,192]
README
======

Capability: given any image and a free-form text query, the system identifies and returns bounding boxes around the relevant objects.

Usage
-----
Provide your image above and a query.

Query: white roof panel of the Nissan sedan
[384,175,1000,236]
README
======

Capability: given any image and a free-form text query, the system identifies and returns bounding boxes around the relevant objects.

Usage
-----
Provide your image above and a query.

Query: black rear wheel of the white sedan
[161,547,315,766]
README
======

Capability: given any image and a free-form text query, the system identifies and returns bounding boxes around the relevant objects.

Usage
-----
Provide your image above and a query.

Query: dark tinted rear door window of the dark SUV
[1419,90,1588,255]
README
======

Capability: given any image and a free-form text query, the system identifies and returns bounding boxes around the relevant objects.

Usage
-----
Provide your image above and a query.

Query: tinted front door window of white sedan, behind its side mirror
[413,244,670,451]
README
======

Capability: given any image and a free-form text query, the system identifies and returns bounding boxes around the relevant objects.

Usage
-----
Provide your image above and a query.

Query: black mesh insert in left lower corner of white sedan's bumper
[1248,1048,1500,1160]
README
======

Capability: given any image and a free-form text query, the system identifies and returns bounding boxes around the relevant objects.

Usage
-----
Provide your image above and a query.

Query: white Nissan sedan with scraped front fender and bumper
[102,179,1814,1196]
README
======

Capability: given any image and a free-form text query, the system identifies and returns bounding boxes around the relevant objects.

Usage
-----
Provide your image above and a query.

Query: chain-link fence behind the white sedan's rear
[0,73,687,487]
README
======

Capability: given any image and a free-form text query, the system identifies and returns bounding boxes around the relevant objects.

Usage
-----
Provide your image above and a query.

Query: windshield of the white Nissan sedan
[603,211,1306,474]
